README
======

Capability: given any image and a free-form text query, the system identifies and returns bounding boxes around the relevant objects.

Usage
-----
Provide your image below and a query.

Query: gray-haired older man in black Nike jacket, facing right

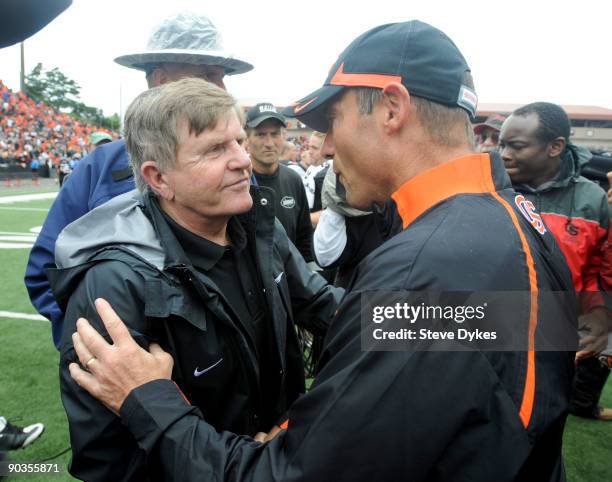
[50,79,342,481]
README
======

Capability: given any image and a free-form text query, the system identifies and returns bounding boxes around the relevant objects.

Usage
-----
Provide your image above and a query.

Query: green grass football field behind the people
[0,188,612,482]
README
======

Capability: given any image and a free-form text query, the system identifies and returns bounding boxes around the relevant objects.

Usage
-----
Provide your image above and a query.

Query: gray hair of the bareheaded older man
[125,78,237,192]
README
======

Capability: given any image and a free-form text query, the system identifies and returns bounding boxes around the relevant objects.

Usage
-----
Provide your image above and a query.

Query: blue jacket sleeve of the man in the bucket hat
[24,141,134,347]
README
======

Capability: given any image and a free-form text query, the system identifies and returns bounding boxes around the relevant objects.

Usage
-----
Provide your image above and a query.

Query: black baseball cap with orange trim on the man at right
[283,20,478,132]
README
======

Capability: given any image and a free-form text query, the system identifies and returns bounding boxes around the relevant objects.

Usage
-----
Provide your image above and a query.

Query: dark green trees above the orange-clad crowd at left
[25,63,119,131]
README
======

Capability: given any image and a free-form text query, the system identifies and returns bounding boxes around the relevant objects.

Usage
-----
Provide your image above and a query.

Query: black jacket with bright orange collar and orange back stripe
[111,155,577,482]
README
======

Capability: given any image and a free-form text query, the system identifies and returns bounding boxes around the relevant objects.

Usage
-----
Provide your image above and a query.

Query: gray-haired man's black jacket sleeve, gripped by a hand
[60,261,148,482]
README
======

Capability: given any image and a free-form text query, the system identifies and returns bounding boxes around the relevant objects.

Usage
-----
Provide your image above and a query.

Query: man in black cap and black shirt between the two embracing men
[246,103,313,262]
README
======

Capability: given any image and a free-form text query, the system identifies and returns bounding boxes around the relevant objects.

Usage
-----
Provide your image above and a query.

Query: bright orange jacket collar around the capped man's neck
[391,153,511,229]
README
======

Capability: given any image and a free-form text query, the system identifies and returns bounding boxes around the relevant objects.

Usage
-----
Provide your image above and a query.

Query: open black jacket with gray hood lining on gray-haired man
[50,187,342,481]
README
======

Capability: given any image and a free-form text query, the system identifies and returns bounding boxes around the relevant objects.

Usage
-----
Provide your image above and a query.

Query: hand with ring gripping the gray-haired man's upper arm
[69,298,174,414]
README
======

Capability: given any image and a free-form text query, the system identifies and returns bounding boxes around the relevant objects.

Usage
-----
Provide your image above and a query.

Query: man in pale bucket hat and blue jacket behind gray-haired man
[25,13,253,347]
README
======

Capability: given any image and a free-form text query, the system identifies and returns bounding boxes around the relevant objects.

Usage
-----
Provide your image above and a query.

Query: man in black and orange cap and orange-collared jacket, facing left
[70,21,576,482]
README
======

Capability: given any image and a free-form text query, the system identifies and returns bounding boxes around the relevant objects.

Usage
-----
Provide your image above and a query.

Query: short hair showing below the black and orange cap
[355,72,474,148]
